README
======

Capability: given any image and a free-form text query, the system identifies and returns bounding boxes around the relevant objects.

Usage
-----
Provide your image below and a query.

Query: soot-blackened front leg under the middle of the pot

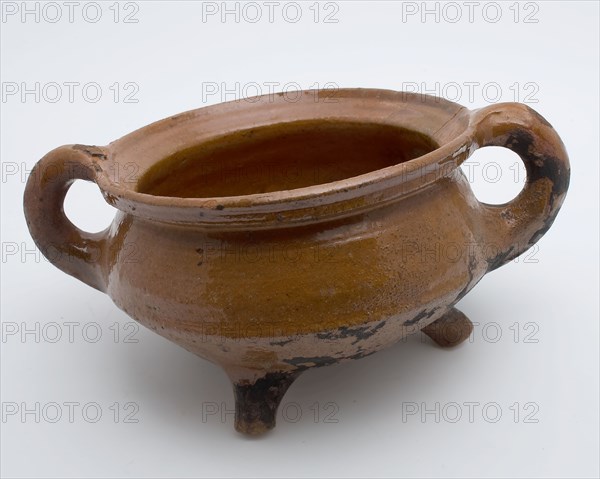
[233,371,300,436]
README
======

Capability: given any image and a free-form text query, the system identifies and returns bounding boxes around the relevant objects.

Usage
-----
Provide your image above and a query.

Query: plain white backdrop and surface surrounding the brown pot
[1,1,599,477]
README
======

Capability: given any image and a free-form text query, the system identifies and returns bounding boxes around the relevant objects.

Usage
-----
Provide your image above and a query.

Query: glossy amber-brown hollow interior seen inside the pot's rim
[137,120,438,198]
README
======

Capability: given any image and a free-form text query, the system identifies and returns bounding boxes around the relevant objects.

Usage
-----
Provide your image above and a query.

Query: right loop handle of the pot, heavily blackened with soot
[472,103,570,271]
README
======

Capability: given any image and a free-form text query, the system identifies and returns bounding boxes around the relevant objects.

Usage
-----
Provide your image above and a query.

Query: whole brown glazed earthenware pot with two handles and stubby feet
[24,89,569,434]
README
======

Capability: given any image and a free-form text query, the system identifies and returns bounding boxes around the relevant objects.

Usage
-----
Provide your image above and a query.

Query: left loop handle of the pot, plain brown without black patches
[23,145,108,291]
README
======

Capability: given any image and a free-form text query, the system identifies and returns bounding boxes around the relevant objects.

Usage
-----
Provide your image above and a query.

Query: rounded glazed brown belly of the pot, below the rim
[109,179,486,370]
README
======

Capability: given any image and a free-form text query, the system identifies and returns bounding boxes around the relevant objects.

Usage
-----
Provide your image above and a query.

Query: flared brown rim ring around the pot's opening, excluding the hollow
[96,88,476,228]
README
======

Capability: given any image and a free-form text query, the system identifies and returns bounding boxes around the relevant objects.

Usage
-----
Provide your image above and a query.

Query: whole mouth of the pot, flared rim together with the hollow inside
[100,88,472,229]
